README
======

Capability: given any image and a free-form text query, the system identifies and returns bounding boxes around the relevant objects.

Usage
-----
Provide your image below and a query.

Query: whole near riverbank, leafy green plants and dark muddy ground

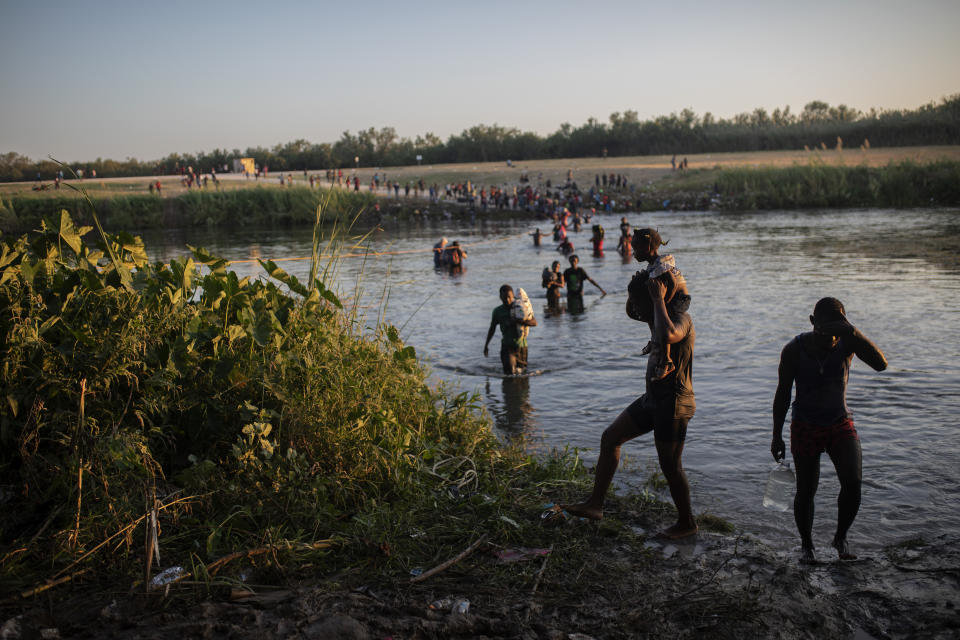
[0,212,957,638]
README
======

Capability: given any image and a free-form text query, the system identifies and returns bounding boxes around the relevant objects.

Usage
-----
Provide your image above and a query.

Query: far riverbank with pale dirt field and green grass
[0,147,960,233]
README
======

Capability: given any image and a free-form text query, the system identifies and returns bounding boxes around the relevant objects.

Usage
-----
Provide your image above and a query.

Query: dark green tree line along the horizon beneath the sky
[0,94,960,182]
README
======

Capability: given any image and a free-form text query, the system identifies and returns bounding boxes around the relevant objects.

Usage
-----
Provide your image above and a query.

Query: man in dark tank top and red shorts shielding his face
[770,298,887,563]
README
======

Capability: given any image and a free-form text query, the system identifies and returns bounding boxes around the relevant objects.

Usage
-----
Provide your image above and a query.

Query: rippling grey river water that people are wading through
[145,210,960,552]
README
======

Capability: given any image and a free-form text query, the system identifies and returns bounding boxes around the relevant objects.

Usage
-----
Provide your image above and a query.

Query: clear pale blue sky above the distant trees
[0,0,960,162]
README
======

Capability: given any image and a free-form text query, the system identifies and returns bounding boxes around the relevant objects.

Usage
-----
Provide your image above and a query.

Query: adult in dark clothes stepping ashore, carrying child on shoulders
[563,278,697,538]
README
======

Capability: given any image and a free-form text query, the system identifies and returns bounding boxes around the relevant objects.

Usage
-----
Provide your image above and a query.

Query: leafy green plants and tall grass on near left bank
[0,201,581,596]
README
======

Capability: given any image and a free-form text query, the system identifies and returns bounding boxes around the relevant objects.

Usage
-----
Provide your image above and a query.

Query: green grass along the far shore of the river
[7,154,960,233]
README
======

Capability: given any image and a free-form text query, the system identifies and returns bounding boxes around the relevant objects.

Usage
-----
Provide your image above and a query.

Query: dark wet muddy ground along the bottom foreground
[0,513,960,640]
